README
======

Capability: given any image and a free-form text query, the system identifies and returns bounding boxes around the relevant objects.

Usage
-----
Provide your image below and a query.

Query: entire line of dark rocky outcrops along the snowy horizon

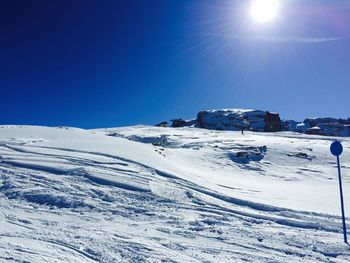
[157,109,350,137]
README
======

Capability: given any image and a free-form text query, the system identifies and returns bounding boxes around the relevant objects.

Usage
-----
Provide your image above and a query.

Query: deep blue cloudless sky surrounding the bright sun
[0,0,350,128]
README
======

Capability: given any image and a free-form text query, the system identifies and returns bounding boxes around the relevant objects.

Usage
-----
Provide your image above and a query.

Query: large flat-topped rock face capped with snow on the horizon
[195,109,282,132]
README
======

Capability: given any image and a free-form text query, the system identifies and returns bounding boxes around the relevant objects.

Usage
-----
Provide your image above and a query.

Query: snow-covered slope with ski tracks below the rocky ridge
[0,126,350,262]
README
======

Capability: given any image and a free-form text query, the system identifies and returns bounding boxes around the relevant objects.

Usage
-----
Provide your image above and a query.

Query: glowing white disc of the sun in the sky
[250,0,280,23]
